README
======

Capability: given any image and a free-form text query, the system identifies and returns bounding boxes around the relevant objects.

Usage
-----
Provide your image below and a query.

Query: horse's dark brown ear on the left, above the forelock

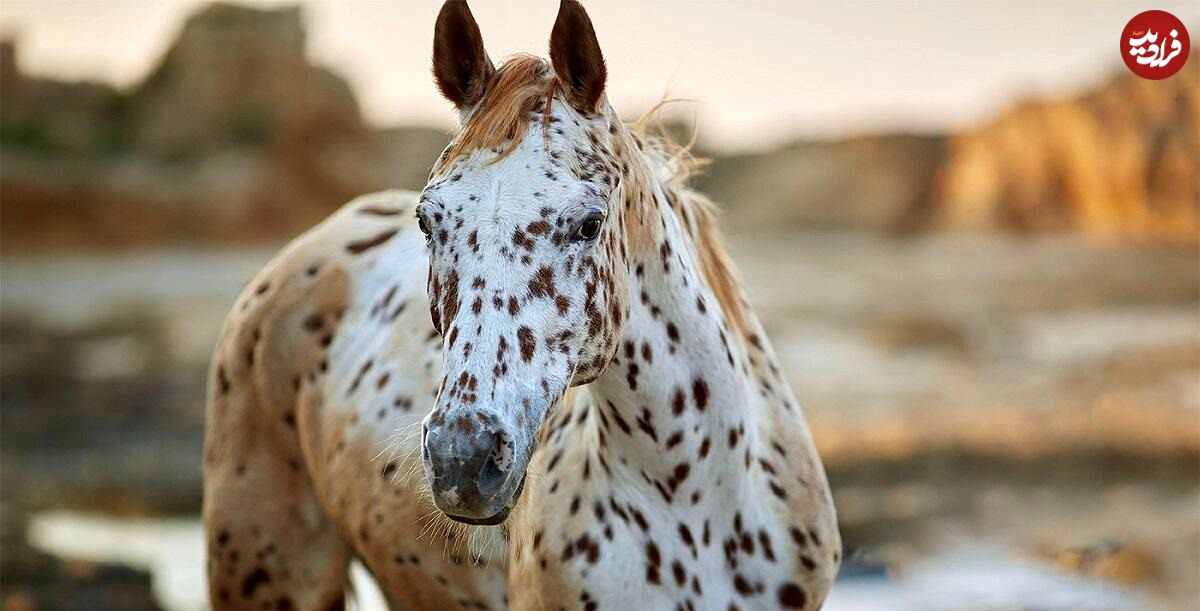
[433,0,496,110]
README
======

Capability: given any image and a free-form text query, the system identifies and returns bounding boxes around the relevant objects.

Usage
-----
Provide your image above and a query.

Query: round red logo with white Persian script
[1121,11,1192,80]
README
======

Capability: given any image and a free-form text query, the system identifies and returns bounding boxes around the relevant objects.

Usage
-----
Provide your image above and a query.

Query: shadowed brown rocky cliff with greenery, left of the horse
[0,4,446,252]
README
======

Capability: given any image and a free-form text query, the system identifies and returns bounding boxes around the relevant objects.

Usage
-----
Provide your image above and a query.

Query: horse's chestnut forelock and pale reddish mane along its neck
[433,54,746,330]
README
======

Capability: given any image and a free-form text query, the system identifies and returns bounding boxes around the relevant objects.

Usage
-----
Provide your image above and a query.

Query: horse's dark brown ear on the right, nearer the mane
[550,0,608,113]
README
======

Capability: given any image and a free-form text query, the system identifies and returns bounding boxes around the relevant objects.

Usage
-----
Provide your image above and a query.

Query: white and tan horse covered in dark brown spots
[204,0,841,611]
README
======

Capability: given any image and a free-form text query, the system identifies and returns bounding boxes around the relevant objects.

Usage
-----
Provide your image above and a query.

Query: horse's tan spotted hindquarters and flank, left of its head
[204,191,505,610]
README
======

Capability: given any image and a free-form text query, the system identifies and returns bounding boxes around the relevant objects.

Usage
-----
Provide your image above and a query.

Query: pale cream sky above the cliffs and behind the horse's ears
[0,0,1200,148]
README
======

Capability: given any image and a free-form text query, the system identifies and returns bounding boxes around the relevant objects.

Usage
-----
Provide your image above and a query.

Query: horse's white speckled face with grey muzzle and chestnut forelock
[416,2,628,525]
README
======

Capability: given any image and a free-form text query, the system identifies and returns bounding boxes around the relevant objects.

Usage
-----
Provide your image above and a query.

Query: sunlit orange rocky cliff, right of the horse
[698,70,1200,241]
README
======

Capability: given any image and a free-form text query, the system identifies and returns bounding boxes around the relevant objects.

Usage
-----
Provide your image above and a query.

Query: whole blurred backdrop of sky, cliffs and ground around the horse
[0,0,1200,611]
